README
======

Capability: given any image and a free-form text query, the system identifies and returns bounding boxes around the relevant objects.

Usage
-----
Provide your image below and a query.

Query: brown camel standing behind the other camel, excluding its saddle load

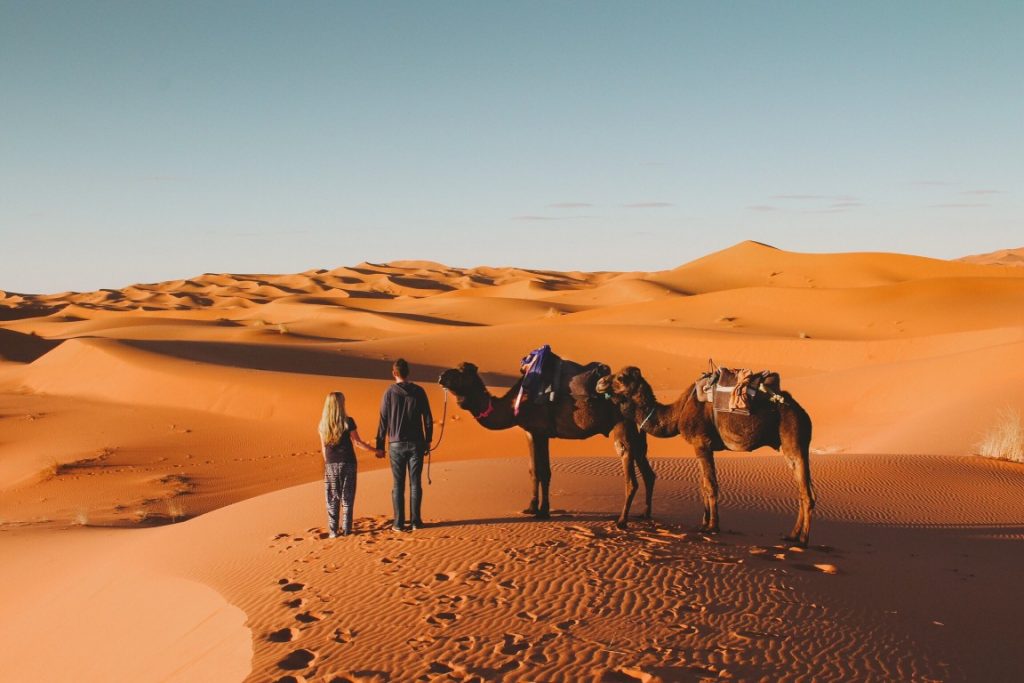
[597,368,814,547]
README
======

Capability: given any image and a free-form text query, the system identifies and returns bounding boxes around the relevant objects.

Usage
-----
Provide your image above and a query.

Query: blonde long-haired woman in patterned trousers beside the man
[318,391,374,539]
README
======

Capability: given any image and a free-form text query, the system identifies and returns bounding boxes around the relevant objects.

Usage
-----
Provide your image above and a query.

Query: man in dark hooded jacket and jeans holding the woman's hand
[377,358,434,531]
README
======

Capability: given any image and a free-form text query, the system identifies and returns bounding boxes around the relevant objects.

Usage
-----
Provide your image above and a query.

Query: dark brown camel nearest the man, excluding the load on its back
[437,362,654,528]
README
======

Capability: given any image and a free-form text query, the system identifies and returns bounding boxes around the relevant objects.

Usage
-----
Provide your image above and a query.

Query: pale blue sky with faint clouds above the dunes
[0,0,1024,292]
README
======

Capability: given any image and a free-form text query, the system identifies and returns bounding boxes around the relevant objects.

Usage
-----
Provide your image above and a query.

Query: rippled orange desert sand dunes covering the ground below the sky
[0,242,1024,682]
